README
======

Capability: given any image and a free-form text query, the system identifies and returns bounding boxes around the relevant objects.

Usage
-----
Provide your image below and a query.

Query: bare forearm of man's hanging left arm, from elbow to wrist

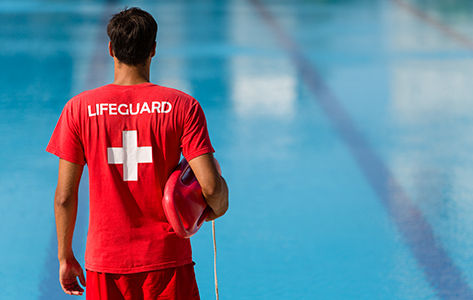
[54,196,77,261]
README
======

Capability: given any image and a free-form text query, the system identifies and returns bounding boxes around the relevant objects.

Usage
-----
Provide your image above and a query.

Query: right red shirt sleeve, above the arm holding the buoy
[181,100,215,161]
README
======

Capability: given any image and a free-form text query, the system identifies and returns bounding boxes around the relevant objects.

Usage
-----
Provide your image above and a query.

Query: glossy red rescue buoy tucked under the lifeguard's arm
[163,159,220,238]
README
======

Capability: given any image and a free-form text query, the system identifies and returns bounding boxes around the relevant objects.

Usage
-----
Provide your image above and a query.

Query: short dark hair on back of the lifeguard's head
[107,7,158,65]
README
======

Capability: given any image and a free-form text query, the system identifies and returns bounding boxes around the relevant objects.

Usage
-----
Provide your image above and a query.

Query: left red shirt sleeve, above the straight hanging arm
[46,101,86,165]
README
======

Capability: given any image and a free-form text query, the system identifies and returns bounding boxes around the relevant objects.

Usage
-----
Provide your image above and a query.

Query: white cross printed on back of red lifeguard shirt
[107,130,153,181]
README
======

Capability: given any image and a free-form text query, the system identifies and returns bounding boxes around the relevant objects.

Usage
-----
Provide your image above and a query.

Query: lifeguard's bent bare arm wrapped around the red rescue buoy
[189,154,228,221]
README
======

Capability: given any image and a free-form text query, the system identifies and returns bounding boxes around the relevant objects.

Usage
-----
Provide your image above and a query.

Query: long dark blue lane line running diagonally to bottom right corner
[249,0,473,300]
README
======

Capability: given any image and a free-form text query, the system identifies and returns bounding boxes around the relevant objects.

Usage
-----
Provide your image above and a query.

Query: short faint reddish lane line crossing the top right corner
[392,0,473,51]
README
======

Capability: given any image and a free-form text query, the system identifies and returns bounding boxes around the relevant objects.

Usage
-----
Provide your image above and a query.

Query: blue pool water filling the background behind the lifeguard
[0,0,473,300]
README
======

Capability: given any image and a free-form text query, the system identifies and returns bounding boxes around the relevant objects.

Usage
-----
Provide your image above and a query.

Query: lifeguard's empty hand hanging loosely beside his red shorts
[59,257,85,296]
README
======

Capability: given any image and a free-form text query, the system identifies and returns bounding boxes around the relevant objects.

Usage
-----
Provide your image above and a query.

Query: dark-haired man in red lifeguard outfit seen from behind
[46,8,228,300]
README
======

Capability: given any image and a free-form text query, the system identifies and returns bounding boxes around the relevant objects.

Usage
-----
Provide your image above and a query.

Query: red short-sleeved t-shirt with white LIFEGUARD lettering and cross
[46,83,214,274]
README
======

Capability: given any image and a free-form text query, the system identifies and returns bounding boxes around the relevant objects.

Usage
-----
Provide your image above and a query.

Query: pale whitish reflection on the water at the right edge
[391,59,473,125]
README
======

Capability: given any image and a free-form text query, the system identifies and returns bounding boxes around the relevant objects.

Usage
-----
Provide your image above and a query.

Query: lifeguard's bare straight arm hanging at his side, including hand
[54,159,85,295]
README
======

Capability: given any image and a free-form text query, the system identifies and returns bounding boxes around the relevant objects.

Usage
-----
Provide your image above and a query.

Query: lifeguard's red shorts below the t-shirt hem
[85,263,200,300]
